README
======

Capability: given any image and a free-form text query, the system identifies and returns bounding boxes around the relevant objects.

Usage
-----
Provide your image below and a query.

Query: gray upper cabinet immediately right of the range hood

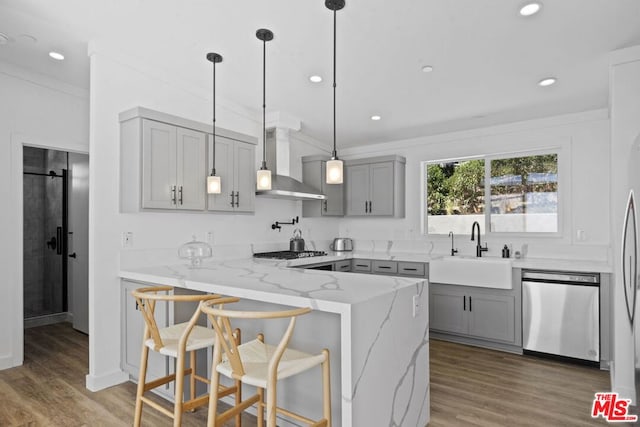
[302,156,344,217]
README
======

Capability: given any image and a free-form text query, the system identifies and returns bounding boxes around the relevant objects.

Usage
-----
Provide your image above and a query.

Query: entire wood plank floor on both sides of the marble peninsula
[0,324,620,427]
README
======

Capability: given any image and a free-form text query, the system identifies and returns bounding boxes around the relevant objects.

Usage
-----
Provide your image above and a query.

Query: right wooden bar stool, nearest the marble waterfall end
[200,298,331,427]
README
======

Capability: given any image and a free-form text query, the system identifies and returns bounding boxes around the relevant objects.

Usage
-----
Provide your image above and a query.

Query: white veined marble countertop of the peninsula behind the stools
[120,256,423,313]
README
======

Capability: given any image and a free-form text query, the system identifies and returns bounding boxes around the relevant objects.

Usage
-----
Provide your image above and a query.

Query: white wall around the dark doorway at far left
[0,62,89,369]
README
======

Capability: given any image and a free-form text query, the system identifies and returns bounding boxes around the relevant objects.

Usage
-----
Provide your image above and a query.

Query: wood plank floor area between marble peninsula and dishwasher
[429,340,610,427]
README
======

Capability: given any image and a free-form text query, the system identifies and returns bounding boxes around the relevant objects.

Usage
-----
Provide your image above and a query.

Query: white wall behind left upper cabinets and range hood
[87,43,337,390]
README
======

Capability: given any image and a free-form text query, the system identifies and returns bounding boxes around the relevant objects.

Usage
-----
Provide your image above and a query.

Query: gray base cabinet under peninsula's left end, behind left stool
[120,280,174,400]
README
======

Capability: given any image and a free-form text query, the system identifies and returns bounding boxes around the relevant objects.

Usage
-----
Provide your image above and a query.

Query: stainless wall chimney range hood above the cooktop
[256,128,327,200]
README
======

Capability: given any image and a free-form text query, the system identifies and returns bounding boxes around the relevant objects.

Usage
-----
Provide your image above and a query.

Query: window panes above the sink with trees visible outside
[425,153,559,234]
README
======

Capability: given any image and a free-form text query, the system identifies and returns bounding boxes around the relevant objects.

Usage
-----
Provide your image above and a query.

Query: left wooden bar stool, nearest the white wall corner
[131,286,242,427]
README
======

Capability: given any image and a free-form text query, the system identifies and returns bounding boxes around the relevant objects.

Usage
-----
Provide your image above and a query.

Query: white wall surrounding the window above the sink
[339,110,610,261]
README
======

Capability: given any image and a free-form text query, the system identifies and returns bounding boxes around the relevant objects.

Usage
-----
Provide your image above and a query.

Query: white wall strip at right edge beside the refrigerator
[610,46,640,403]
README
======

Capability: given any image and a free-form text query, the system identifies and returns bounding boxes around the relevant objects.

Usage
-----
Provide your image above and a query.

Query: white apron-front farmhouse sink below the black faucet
[429,256,513,289]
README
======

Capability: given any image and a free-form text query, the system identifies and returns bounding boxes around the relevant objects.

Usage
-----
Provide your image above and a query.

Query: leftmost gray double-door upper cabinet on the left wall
[142,119,206,210]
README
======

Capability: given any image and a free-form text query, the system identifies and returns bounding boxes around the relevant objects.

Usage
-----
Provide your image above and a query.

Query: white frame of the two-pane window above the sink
[421,146,569,238]
